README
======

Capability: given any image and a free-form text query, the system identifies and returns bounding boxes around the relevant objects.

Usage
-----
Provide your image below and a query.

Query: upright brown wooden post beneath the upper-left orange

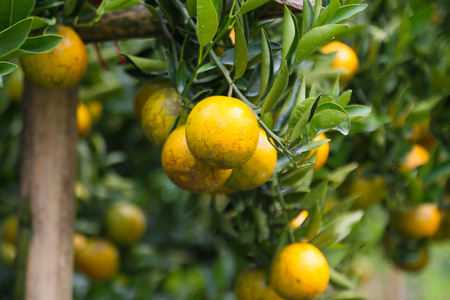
[19,81,78,300]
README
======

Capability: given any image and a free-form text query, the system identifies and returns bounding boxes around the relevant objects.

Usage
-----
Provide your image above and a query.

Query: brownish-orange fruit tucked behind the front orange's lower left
[161,126,232,193]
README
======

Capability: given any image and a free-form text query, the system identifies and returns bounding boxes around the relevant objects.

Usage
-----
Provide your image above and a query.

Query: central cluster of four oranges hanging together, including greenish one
[135,83,277,193]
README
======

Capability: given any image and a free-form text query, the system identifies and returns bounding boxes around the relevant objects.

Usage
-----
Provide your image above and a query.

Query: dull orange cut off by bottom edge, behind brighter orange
[235,268,283,300]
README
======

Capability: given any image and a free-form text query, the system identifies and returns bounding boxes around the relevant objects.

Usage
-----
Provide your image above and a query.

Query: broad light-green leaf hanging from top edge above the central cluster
[197,0,218,47]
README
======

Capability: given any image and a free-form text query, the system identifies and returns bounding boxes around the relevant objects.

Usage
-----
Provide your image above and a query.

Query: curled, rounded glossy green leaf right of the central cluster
[309,103,350,136]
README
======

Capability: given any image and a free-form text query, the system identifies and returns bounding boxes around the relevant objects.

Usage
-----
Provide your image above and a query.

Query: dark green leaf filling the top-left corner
[0,0,36,31]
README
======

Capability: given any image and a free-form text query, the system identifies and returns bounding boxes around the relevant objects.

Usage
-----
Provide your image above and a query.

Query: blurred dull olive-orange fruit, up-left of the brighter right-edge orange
[347,168,386,209]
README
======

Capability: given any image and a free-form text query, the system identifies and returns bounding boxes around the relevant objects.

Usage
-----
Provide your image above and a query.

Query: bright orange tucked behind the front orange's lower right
[225,128,277,191]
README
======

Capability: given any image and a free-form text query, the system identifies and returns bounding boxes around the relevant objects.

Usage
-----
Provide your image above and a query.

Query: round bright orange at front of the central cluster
[186,96,259,169]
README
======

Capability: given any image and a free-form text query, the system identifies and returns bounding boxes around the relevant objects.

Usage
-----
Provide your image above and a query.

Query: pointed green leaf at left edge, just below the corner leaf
[0,18,33,58]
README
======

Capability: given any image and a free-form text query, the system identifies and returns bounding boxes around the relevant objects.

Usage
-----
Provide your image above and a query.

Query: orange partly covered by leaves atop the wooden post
[20,25,88,89]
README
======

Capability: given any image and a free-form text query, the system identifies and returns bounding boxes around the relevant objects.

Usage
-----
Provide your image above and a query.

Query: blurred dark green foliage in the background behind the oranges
[0,0,450,300]
